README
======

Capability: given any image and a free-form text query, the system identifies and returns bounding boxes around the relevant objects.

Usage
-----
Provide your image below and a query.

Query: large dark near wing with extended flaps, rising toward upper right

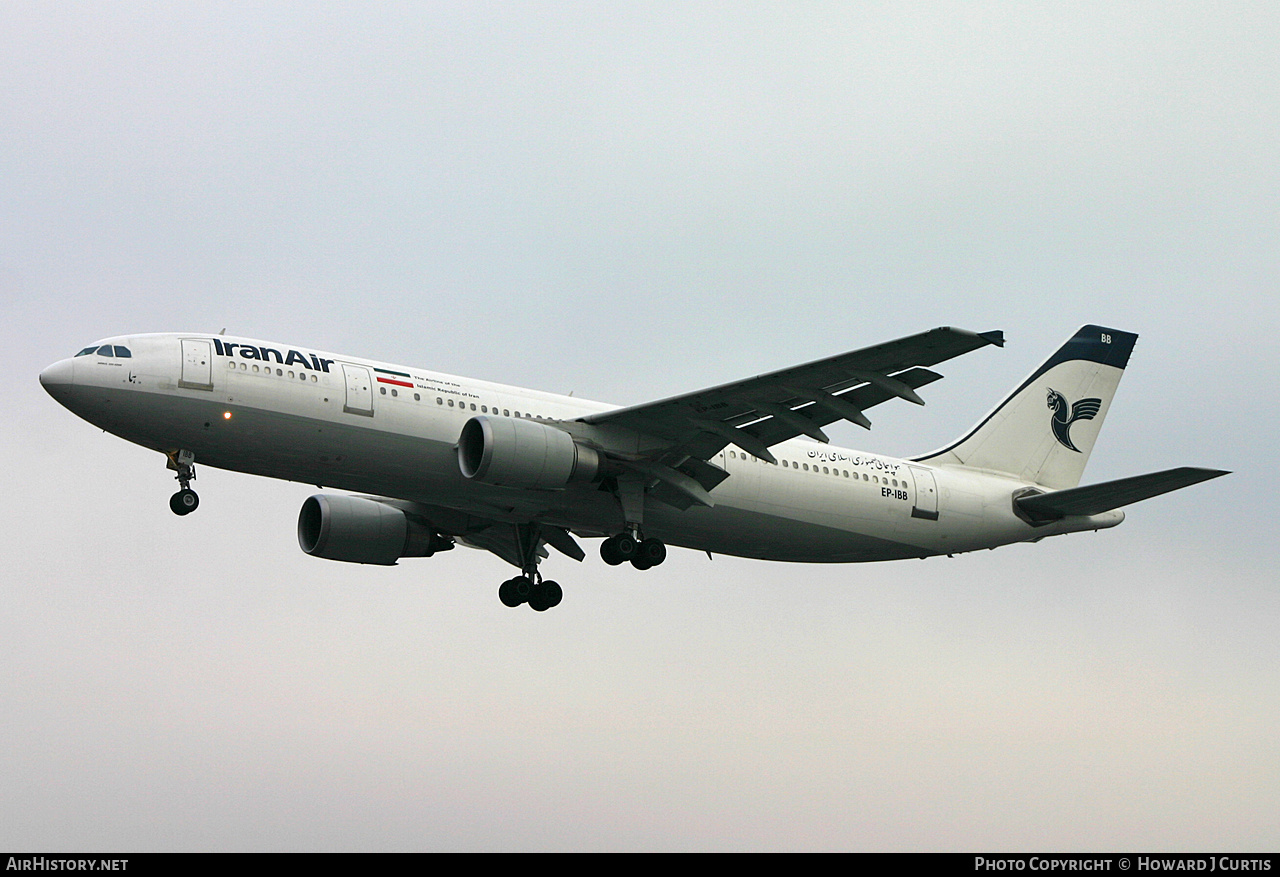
[581,328,1005,468]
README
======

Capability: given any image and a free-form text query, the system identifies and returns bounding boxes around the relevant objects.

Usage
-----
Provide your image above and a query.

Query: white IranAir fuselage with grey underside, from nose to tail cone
[41,334,1123,562]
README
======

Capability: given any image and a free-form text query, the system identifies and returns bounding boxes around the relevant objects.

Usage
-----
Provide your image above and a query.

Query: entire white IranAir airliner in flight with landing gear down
[40,325,1228,612]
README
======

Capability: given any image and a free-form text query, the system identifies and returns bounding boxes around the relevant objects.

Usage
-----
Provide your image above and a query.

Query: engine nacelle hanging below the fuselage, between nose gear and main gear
[298,493,453,566]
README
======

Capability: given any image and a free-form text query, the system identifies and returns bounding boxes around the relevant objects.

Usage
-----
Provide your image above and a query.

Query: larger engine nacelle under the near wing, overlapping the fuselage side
[458,415,600,489]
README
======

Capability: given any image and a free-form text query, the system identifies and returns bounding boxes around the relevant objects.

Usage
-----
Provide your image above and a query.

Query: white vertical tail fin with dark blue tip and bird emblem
[916,325,1138,490]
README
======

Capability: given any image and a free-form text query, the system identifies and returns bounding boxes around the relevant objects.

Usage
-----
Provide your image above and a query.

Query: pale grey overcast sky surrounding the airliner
[0,0,1280,851]
